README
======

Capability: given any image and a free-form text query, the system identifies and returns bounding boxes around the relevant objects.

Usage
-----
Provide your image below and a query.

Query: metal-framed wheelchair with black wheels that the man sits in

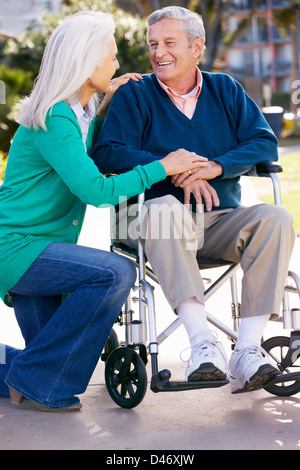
[101,162,300,408]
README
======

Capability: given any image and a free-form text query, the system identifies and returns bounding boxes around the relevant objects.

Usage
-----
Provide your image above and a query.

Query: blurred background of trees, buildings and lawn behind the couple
[0,0,300,234]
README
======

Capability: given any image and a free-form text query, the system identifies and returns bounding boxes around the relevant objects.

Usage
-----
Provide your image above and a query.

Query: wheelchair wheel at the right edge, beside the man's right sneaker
[261,336,300,397]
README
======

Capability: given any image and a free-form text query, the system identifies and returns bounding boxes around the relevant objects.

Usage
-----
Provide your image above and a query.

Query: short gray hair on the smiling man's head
[147,6,205,46]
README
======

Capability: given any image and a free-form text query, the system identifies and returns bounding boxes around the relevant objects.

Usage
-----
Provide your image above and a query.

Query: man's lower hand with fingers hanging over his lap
[183,179,220,212]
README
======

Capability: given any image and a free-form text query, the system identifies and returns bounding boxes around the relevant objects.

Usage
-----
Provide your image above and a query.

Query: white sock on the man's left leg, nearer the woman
[176,297,211,347]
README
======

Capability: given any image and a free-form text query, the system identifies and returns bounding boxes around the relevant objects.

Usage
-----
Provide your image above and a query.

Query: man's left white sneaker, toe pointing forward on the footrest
[188,331,227,381]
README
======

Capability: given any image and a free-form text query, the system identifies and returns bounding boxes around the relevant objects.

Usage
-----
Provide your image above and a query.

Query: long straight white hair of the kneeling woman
[17,11,115,130]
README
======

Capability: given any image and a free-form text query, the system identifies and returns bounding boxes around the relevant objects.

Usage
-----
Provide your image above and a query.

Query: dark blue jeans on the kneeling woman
[0,242,136,408]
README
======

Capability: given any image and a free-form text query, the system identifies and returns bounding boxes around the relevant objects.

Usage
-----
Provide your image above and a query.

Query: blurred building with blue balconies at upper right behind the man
[225,0,299,104]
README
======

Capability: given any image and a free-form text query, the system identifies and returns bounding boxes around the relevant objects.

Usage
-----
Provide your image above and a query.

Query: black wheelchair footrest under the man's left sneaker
[150,369,229,393]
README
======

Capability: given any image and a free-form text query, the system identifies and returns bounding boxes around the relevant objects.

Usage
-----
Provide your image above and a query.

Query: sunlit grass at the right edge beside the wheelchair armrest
[253,149,300,236]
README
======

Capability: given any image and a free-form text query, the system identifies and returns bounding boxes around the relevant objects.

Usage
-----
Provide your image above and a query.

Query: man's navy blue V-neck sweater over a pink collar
[92,72,278,209]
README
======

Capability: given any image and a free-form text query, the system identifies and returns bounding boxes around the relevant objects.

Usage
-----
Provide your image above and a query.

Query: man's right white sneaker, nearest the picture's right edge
[229,344,280,393]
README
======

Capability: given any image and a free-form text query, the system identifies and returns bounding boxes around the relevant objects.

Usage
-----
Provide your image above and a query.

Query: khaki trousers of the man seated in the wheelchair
[116,196,295,319]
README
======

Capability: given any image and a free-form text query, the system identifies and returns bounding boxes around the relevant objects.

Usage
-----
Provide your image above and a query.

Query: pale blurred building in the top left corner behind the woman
[0,0,61,34]
